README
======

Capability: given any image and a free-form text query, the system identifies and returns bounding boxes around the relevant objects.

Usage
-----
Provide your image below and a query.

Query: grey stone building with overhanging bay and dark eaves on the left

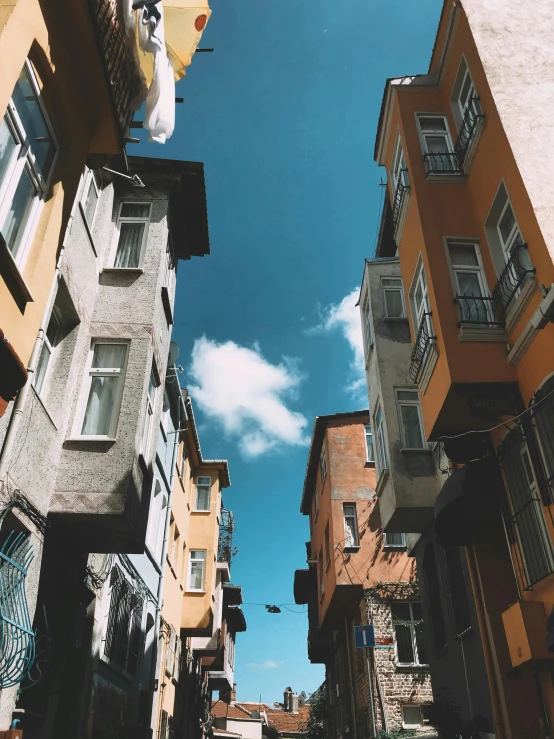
[0,157,209,739]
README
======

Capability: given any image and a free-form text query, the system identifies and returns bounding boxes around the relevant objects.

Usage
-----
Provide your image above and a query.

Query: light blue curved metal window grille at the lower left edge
[0,531,35,689]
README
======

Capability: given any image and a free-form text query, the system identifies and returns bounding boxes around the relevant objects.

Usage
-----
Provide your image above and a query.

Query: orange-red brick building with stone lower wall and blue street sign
[294,410,431,739]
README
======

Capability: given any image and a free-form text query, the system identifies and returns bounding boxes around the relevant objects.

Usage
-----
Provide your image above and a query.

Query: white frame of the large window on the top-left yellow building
[0,58,60,272]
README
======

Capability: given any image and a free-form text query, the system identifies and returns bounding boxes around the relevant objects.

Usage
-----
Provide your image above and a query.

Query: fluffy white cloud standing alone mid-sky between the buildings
[189,336,308,457]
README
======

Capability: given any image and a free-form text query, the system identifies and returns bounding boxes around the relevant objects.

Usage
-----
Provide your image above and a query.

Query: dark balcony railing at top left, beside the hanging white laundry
[88,0,139,138]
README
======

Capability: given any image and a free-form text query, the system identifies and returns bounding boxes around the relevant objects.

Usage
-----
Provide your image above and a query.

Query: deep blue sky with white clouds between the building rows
[139,0,442,703]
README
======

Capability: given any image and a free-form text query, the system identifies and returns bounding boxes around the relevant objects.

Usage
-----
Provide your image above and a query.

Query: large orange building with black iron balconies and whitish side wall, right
[368,0,554,737]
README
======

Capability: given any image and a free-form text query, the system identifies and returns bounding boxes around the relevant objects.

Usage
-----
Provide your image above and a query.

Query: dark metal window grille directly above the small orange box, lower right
[499,428,554,589]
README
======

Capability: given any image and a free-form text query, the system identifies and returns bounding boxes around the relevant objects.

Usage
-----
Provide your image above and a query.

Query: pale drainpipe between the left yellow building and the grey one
[0,214,75,482]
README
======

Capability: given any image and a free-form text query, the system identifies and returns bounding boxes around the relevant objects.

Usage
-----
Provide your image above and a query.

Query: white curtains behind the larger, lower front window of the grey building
[81,344,127,436]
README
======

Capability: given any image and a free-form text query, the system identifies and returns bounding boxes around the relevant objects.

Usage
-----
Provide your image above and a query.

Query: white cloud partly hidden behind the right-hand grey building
[312,287,367,402]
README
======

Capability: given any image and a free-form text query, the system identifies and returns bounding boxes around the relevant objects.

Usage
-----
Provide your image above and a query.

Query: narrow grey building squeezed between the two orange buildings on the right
[360,199,493,736]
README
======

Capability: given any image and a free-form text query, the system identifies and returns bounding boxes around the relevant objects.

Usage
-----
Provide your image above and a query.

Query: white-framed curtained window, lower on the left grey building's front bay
[81,341,128,438]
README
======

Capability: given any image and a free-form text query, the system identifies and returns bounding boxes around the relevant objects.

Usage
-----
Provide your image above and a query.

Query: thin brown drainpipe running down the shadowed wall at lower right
[466,544,512,739]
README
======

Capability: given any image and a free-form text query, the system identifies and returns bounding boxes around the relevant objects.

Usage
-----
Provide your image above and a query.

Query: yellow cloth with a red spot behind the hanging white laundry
[139,0,212,85]
